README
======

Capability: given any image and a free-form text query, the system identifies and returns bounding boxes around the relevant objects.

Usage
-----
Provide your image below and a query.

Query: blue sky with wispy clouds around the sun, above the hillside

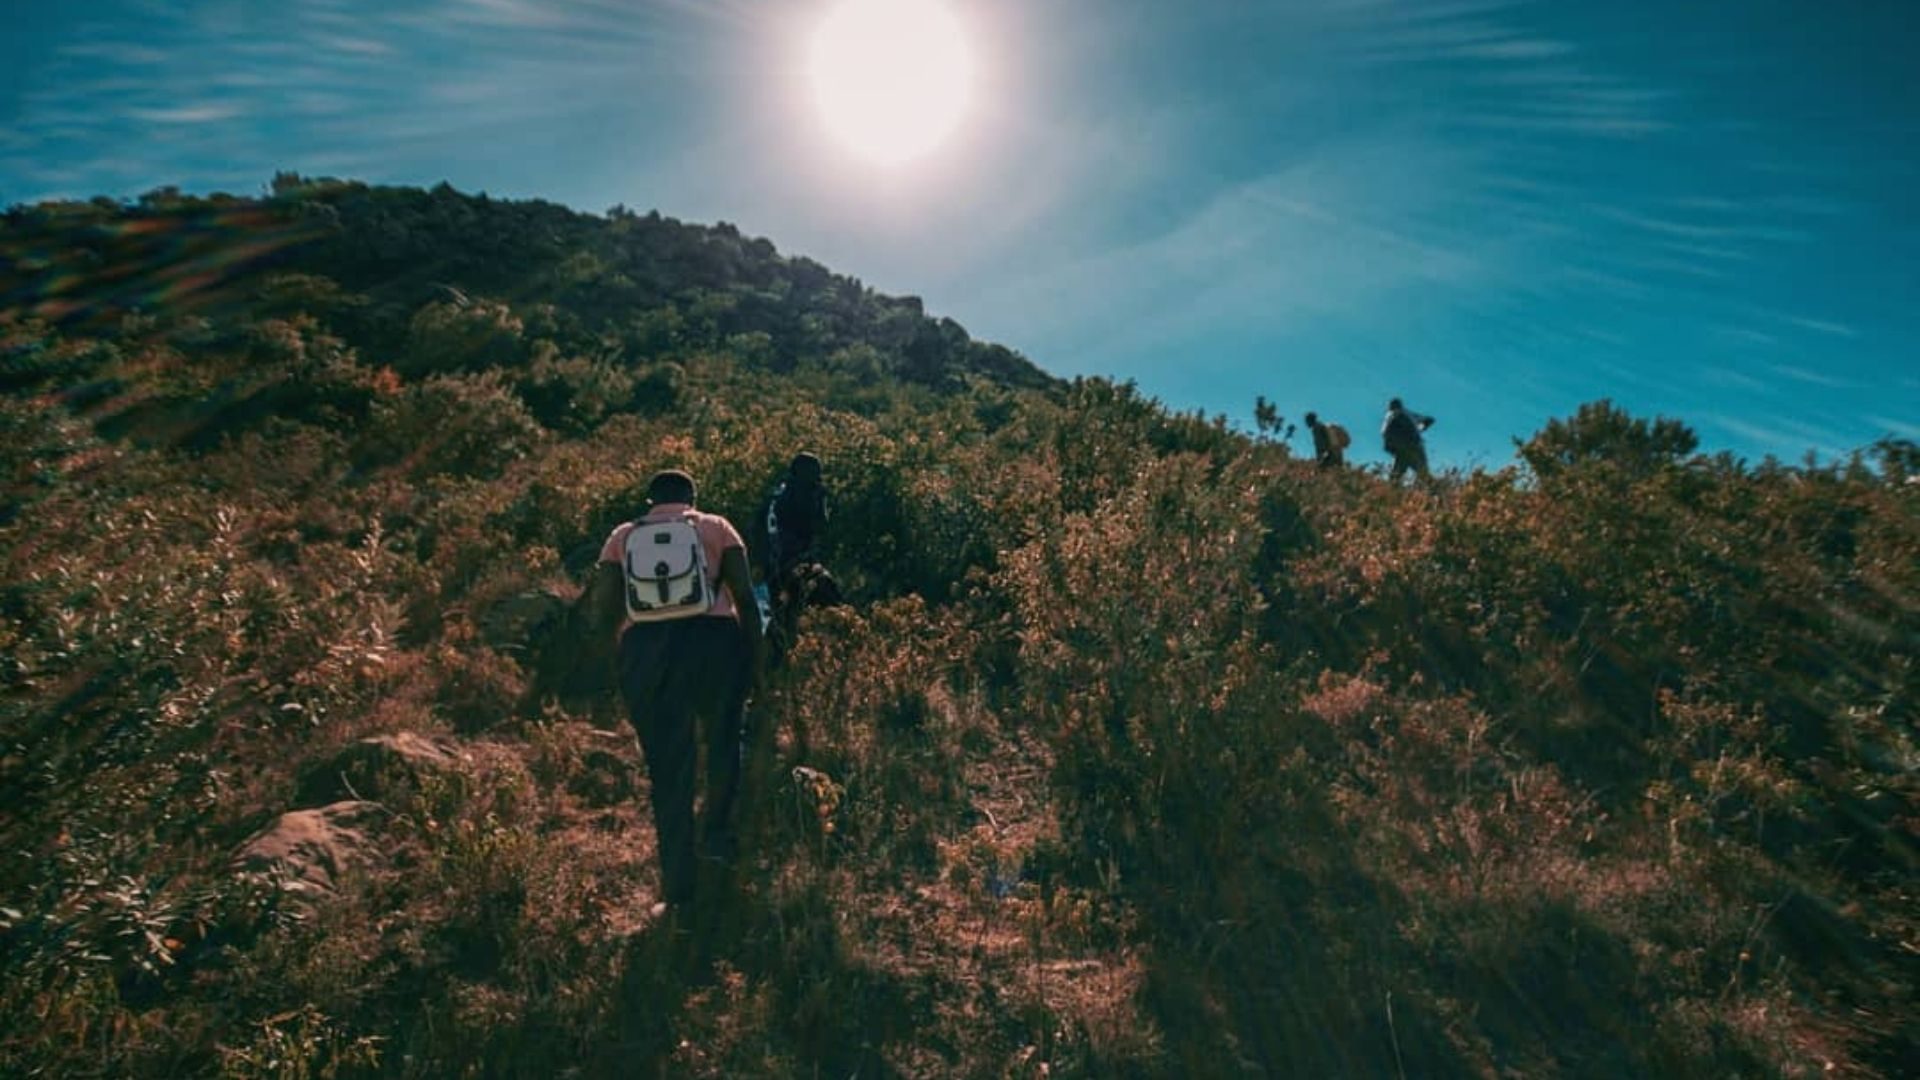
[0,0,1920,465]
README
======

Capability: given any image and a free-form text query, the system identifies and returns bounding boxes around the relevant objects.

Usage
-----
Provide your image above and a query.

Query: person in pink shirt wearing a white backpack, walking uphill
[593,469,764,913]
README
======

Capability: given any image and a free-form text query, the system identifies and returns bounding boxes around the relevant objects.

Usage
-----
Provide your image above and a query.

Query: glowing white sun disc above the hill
[806,0,973,165]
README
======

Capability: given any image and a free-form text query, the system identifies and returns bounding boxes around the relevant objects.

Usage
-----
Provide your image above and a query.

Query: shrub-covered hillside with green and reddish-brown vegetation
[0,175,1920,1078]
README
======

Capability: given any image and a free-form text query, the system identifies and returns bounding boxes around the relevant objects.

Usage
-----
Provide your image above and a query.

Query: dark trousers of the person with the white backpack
[620,615,749,903]
